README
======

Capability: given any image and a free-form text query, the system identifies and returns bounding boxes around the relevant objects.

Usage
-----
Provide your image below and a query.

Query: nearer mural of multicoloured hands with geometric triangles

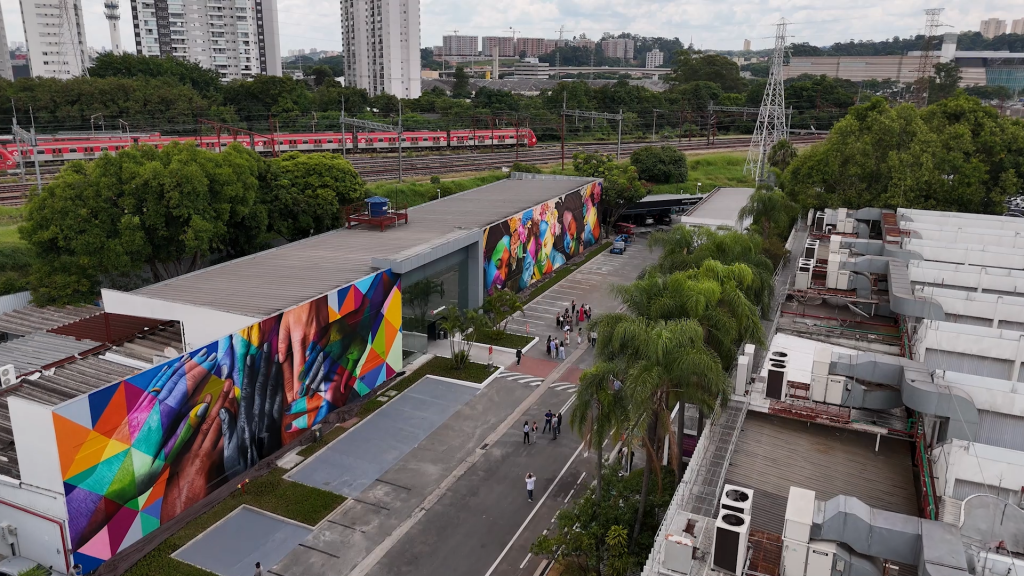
[53,271,401,572]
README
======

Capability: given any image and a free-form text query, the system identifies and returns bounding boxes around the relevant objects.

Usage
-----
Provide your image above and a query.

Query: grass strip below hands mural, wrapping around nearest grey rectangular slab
[125,468,345,576]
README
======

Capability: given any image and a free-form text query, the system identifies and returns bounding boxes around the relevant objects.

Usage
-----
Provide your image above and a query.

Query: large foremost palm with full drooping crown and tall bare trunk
[596,313,729,543]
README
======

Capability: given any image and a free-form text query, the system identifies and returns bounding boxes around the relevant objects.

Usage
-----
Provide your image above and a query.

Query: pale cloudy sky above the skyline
[0,0,1024,54]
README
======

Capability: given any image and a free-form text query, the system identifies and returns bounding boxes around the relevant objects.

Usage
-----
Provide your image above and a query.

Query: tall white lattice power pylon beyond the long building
[749,18,790,182]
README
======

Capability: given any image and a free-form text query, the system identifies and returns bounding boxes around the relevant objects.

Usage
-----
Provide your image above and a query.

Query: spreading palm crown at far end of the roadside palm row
[644,227,775,316]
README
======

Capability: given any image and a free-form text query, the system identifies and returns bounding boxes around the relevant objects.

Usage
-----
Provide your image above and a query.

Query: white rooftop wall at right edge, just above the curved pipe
[931,440,1024,496]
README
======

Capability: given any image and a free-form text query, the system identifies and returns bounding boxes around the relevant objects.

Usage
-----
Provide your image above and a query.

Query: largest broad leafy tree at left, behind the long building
[19,142,266,305]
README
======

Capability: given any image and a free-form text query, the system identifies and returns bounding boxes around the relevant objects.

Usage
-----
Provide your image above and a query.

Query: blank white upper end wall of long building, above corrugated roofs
[102,289,260,348]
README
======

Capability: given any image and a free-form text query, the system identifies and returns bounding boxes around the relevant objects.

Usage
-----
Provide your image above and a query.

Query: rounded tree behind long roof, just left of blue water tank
[268,152,366,240]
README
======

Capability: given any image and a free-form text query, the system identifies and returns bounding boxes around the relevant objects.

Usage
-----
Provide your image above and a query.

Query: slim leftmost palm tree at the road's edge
[569,362,627,502]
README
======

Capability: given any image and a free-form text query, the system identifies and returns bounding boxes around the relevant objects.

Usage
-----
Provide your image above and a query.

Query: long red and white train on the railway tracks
[0,128,537,171]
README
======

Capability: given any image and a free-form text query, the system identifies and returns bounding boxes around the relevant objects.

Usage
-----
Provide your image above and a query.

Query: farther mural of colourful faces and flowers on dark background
[483,182,601,294]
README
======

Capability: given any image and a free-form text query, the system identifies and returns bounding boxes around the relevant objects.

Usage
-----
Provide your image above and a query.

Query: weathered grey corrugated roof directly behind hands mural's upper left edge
[0,354,141,479]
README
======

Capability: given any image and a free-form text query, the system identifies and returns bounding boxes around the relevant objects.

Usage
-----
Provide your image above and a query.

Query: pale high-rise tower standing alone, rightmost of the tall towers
[341,0,420,98]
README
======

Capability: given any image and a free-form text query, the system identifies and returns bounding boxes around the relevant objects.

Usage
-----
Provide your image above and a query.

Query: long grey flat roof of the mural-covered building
[133,177,595,318]
